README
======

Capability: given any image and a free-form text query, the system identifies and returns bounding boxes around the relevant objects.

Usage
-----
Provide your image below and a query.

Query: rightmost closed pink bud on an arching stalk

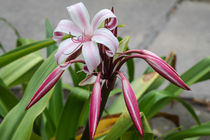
[145,56,190,90]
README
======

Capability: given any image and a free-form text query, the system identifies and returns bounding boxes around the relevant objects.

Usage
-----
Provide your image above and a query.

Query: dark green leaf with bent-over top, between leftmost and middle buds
[56,85,89,140]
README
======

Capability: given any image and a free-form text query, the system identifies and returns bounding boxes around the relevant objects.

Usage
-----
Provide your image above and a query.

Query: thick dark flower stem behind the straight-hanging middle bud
[81,77,116,140]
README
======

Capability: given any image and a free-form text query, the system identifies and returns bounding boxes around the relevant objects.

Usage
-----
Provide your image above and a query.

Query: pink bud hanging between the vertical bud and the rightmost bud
[118,72,144,137]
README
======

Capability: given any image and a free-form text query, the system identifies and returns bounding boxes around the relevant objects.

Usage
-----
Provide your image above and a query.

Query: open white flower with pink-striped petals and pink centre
[53,2,119,73]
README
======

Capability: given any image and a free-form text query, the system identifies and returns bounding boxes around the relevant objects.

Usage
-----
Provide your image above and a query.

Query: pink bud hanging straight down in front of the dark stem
[89,73,101,140]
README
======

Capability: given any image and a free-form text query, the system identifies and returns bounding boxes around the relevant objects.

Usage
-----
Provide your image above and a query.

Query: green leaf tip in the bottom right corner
[165,122,210,140]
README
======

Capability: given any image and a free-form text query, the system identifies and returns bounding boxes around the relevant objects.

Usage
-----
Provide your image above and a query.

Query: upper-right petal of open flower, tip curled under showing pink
[91,9,117,31]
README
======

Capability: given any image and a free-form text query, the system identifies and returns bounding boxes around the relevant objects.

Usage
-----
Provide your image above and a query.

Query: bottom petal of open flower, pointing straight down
[82,41,101,73]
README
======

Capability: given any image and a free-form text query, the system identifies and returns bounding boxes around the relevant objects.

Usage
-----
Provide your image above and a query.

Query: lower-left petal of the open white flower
[55,38,81,65]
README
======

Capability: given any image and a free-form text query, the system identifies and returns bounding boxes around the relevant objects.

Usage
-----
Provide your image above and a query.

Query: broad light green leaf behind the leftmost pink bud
[0,50,57,140]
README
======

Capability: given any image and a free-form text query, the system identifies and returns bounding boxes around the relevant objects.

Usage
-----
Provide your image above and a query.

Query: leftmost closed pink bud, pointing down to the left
[26,67,64,110]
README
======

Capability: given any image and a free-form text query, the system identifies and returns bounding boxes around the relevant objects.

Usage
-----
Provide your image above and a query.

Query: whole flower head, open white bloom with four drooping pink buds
[26,3,189,139]
